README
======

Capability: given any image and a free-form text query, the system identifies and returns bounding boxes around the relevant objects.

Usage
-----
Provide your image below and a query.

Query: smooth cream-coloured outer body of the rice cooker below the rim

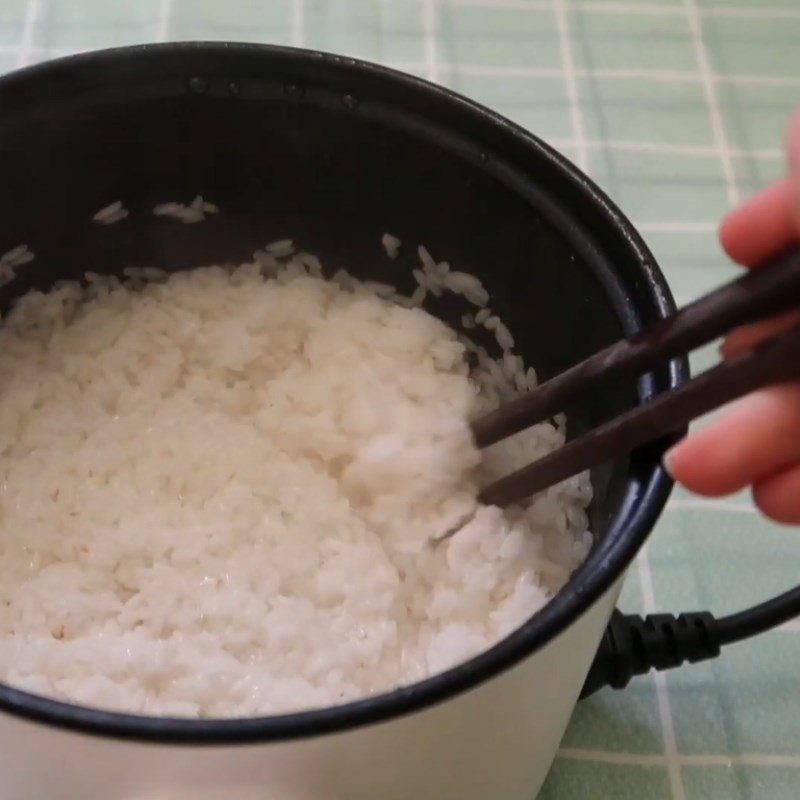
[0,580,621,800]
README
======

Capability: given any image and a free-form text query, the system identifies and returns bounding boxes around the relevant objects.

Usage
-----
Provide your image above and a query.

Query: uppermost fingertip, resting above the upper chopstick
[719,176,800,267]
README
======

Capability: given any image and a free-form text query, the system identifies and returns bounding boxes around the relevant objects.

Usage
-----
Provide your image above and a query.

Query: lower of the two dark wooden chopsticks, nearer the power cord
[478,326,800,506]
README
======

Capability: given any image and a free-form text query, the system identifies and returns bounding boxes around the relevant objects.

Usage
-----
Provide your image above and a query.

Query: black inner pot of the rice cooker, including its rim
[0,43,685,742]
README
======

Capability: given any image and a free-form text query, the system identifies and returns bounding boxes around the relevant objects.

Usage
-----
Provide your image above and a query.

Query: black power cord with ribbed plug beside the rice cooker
[581,586,800,698]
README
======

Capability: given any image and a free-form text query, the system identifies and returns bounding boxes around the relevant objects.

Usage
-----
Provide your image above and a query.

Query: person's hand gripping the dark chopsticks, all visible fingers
[664,113,800,524]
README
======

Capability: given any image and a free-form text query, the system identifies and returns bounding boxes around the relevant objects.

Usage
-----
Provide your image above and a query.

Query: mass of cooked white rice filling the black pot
[0,250,590,717]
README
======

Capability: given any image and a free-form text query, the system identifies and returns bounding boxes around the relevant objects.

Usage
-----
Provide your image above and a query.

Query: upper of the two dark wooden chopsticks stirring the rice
[472,249,800,447]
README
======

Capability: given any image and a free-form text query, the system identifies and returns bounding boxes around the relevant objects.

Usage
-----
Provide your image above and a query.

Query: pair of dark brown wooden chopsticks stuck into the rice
[472,249,800,506]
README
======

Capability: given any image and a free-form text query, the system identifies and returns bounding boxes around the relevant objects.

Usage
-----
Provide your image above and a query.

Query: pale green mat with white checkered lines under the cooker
[0,0,800,800]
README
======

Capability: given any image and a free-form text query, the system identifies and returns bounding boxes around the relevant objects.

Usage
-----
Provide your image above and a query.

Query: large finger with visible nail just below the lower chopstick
[664,384,800,497]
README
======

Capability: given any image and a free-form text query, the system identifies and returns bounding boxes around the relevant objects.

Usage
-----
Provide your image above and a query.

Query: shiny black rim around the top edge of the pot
[0,42,688,745]
